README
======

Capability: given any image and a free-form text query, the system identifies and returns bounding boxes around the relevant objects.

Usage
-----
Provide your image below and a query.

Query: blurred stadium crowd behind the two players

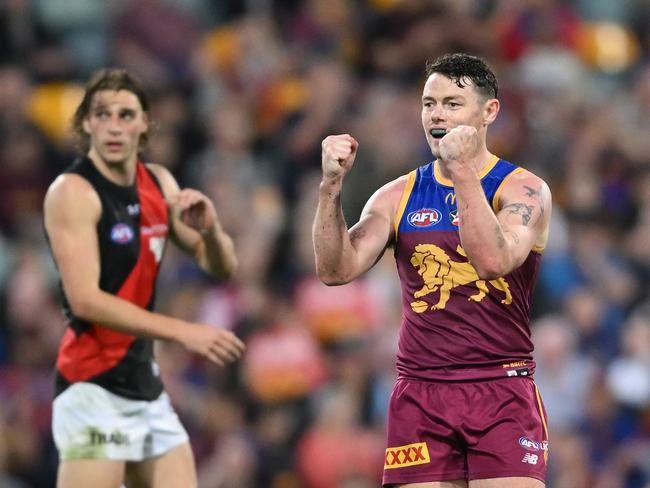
[0,0,650,488]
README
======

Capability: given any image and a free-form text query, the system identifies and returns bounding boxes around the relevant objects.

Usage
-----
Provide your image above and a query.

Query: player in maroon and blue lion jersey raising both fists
[313,54,551,488]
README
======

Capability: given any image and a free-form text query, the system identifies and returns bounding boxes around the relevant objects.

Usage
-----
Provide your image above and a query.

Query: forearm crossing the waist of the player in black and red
[68,290,185,340]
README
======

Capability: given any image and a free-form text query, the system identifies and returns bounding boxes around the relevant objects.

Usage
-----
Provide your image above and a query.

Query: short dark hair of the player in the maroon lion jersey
[425,53,499,99]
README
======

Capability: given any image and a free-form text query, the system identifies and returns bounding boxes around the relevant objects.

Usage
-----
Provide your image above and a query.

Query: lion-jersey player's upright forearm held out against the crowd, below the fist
[312,180,355,285]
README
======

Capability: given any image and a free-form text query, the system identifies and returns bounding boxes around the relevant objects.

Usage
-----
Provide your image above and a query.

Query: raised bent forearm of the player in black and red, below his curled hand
[197,223,237,279]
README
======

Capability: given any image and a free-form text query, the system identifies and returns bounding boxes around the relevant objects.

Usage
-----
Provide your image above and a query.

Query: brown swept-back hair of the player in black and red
[72,68,149,154]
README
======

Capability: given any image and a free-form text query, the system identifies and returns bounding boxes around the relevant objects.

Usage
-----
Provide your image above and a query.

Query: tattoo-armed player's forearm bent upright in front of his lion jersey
[454,176,511,279]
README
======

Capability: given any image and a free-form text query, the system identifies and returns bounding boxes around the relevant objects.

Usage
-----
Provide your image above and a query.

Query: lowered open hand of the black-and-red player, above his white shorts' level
[179,324,246,366]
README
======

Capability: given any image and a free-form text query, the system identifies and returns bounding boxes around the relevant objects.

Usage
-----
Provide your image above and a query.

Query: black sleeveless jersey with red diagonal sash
[48,158,169,400]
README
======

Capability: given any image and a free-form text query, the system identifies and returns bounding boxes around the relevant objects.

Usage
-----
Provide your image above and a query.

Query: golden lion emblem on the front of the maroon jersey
[411,244,512,313]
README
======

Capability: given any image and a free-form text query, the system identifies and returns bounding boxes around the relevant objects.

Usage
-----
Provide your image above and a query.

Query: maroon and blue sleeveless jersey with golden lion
[395,157,541,381]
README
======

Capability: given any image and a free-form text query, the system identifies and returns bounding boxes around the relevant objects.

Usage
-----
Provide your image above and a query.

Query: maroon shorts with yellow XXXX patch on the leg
[383,377,548,486]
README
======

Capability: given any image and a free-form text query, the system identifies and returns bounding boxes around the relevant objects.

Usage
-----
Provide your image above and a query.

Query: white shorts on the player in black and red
[52,382,189,461]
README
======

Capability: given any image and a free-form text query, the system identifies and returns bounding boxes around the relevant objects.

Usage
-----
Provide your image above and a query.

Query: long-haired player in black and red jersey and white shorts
[44,70,244,488]
